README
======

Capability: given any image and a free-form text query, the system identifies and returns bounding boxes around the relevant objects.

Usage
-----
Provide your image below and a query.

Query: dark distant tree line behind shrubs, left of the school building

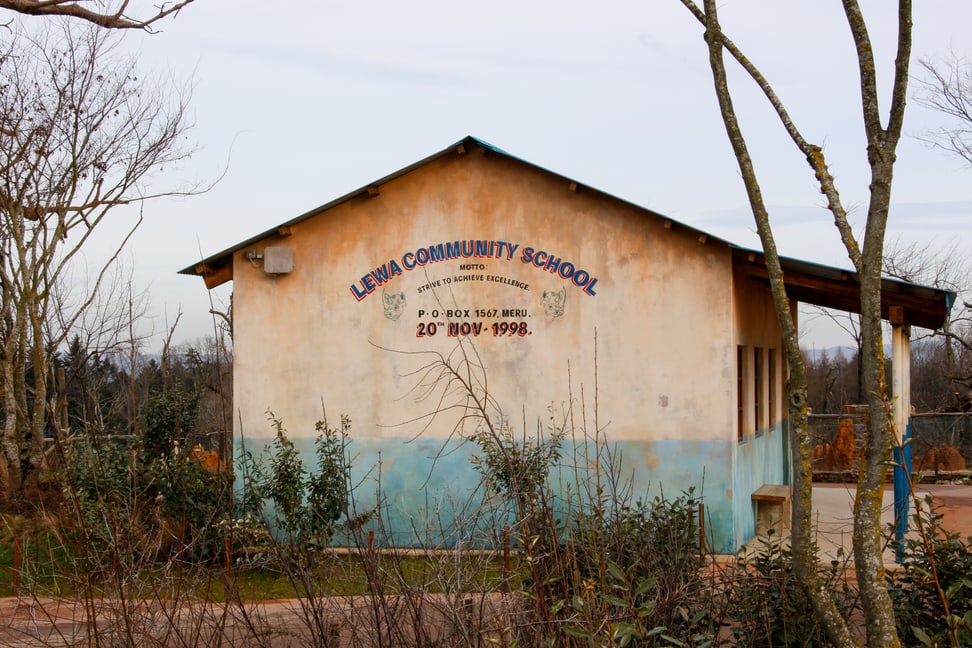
[0,335,233,508]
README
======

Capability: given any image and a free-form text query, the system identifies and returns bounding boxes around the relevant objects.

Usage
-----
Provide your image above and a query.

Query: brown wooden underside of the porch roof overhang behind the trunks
[733,247,955,330]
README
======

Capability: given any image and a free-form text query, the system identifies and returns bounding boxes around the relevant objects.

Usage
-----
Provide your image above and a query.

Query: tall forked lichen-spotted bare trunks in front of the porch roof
[682,0,912,646]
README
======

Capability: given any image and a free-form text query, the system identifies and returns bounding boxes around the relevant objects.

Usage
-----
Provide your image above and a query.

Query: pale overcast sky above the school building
[30,0,972,346]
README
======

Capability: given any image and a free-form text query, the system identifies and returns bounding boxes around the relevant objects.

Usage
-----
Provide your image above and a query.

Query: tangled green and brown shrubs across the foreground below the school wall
[0,322,972,647]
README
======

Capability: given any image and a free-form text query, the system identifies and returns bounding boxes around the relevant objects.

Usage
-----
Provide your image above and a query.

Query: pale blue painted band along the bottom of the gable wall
[237,435,740,553]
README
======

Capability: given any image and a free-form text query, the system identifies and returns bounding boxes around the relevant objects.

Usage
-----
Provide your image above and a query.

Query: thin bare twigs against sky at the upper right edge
[915,54,972,164]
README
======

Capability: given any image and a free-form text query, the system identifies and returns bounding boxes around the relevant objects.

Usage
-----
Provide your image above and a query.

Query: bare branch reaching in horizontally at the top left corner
[0,0,193,31]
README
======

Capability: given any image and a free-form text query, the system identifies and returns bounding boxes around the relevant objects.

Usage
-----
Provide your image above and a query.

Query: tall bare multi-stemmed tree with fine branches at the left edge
[0,25,197,496]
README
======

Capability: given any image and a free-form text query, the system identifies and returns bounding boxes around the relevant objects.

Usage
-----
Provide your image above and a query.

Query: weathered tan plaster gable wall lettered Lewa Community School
[234,149,738,550]
